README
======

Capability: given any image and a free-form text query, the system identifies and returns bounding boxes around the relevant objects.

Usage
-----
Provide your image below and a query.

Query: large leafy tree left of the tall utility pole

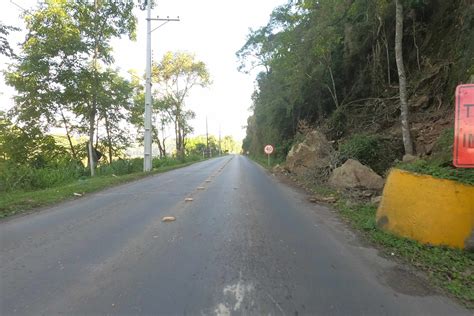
[6,0,136,174]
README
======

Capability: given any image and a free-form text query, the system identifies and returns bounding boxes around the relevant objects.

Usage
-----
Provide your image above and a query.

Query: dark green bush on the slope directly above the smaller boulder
[339,133,402,174]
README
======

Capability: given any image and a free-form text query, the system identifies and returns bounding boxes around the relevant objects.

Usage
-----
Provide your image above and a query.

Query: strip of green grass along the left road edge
[0,160,202,218]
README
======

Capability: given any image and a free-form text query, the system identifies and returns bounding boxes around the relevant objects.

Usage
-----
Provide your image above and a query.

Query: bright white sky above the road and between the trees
[0,0,287,140]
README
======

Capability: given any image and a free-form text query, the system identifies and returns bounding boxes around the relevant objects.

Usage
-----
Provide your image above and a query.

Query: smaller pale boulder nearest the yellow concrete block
[329,159,384,190]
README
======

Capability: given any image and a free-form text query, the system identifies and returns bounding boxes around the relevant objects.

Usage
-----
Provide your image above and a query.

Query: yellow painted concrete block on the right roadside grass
[376,169,474,250]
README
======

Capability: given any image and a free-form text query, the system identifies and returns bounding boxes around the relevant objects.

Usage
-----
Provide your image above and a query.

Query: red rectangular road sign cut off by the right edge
[453,84,474,168]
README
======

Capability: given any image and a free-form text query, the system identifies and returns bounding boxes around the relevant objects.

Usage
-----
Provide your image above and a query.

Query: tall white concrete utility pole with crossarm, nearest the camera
[141,0,179,172]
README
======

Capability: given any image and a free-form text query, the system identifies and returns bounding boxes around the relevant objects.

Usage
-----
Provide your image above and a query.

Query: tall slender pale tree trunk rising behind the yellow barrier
[395,0,413,155]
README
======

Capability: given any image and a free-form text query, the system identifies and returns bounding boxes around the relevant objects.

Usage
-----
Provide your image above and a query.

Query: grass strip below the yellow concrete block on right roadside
[336,199,474,308]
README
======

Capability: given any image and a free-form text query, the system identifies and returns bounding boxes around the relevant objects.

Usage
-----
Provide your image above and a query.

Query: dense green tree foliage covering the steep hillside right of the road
[237,0,393,154]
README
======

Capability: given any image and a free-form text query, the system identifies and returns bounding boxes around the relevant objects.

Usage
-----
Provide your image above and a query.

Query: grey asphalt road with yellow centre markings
[0,156,470,315]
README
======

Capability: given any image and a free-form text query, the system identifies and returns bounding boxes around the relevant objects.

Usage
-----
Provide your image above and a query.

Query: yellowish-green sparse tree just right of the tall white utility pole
[152,52,210,158]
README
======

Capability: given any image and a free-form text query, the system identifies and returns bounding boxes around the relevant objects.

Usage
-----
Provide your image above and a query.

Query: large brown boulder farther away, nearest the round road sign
[286,131,334,175]
